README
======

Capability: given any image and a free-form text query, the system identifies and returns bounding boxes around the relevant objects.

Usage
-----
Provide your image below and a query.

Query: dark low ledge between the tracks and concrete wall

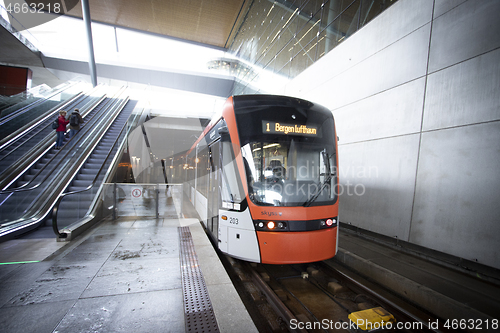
[331,228,500,331]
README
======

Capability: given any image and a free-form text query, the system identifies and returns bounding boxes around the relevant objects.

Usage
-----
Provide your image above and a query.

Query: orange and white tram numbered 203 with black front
[186,95,338,264]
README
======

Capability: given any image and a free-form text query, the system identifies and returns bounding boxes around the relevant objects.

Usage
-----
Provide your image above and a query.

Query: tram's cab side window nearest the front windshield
[221,141,245,203]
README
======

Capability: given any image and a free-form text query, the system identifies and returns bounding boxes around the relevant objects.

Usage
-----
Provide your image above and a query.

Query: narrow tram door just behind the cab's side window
[207,140,221,236]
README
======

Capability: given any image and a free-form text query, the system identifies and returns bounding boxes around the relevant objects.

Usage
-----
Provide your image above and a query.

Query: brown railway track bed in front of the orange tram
[226,257,446,332]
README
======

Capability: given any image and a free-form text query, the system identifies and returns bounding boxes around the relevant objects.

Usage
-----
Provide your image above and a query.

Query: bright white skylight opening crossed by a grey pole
[12,10,225,73]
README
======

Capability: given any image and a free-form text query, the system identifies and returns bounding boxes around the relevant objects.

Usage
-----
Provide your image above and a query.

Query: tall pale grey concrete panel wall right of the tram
[284,0,500,268]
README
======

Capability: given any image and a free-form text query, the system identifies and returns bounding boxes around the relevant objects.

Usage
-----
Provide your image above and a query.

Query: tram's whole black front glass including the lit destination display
[234,96,337,207]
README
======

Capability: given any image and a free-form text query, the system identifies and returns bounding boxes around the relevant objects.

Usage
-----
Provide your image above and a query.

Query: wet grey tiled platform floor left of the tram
[0,217,257,333]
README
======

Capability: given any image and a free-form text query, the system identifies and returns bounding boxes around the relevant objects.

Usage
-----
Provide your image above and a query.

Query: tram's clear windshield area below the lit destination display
[242,138,336,206]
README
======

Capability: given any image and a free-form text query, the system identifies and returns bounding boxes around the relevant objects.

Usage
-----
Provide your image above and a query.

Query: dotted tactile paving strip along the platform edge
[178,227,219,332]
